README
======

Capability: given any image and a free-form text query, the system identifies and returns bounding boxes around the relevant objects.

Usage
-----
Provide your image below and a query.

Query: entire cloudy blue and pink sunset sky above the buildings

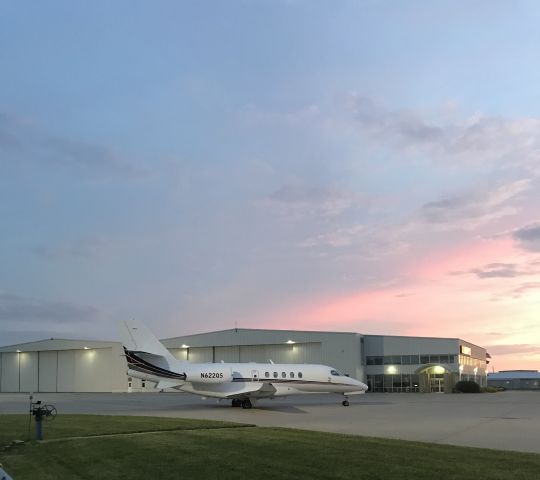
[0,0,540,370]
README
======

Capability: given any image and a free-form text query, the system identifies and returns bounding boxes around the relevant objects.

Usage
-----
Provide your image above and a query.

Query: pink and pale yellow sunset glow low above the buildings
[258,238,540,369]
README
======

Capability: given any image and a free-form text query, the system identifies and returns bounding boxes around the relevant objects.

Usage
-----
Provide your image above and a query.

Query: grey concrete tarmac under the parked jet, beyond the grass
[0,391,540,453]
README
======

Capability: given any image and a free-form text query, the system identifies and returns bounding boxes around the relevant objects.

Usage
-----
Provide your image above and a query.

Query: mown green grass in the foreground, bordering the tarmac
[0,415,540,480]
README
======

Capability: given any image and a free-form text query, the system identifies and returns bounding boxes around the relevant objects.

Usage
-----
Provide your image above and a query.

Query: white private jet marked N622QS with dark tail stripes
[121,322,368,408]
